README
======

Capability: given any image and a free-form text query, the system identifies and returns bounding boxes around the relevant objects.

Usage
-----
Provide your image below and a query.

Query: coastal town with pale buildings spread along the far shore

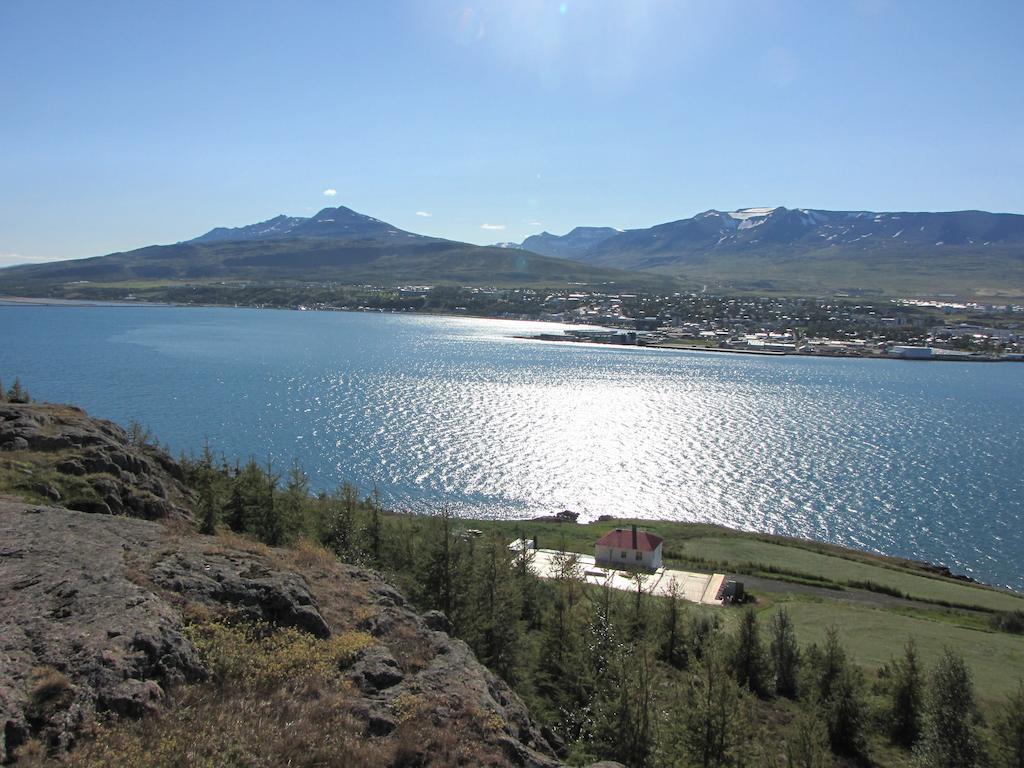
[415,288,1024,361]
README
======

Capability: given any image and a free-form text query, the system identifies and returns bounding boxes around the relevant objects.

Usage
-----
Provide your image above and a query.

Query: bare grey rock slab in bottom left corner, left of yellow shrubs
[0,501,206,759]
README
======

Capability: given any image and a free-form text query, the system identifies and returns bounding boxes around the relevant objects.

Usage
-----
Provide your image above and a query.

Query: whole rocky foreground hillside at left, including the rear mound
[0,403,606,768]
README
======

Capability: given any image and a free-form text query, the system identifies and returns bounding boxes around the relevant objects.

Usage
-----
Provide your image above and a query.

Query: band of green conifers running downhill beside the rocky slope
[183,450,1024,768]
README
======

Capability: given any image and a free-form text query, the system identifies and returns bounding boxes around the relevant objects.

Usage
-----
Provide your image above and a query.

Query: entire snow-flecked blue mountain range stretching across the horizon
[0,206,1024,298]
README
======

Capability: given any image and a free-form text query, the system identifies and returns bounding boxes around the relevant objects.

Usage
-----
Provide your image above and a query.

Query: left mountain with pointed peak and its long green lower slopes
[0,206,659,297]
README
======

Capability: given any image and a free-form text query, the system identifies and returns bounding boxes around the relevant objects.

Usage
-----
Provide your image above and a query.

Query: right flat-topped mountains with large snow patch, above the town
[503,207,1024,297]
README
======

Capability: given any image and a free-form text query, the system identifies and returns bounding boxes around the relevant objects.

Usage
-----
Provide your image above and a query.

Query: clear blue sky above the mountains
[0,0,1024,264]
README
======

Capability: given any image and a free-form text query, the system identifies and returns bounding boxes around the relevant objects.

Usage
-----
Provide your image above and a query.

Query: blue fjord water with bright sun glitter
[6,306,1024,590]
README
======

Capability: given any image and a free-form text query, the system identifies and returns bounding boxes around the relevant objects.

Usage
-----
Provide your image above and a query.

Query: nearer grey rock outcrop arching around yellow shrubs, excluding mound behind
[0,499,559,767]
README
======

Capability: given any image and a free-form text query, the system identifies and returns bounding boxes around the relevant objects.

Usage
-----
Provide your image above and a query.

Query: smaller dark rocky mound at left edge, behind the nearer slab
[0,403,190,520]
